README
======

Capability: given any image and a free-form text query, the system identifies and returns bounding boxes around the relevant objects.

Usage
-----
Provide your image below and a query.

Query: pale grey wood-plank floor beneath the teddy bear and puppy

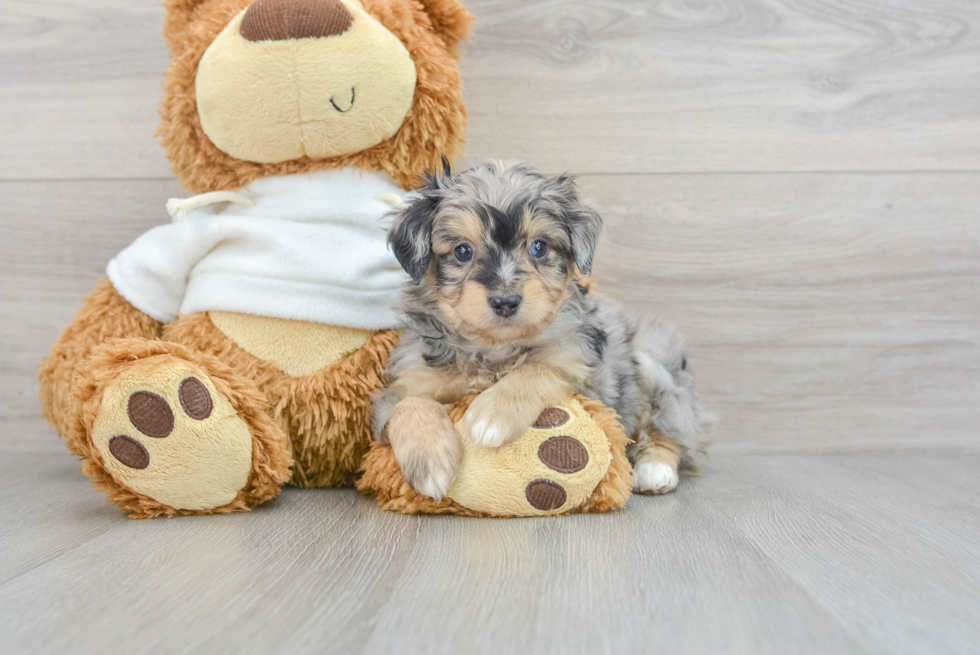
[0,451,980,655]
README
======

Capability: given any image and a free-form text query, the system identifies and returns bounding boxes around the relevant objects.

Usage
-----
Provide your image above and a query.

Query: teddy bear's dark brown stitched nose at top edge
[241,0,354,41]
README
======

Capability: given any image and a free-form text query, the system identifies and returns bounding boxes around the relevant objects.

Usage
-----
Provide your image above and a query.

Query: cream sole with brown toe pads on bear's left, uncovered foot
[92,358,252,510]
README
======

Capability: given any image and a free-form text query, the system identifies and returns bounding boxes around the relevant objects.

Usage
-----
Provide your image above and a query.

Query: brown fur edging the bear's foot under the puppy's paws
[357,394,633,518]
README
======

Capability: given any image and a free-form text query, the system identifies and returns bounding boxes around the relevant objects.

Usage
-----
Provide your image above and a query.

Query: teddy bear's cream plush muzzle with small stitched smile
[196,1,416,164]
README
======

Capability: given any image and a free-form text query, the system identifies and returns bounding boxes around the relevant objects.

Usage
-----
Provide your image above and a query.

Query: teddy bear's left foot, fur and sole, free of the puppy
[78,339,291,517]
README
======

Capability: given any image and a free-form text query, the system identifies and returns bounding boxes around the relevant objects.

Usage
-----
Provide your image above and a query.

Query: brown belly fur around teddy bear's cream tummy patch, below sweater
[163,313,398,487]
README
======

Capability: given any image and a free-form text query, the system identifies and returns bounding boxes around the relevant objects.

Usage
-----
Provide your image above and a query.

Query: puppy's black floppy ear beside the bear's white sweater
[388,164,451,283]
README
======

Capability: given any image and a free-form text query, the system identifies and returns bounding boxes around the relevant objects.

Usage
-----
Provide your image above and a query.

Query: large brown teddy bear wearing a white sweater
[40,0,629,518]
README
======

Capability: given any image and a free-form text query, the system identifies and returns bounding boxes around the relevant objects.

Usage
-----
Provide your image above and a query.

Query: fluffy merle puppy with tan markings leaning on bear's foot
[372,161,708,499]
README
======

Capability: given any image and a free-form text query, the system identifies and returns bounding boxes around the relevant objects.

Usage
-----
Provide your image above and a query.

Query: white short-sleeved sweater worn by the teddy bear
[107,168,408,330]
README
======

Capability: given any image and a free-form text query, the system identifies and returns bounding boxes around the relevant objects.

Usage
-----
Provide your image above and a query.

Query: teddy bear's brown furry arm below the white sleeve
[38,278,163,436]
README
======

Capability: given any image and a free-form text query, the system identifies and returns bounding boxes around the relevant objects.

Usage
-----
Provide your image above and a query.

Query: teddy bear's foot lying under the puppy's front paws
[357,395,633,516]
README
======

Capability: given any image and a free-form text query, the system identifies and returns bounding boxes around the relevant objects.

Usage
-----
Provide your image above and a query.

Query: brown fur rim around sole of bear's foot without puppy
[65,339,292,518]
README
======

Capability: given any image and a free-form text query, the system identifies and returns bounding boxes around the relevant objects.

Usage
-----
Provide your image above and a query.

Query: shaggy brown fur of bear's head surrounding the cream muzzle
[158,0,472,193]
